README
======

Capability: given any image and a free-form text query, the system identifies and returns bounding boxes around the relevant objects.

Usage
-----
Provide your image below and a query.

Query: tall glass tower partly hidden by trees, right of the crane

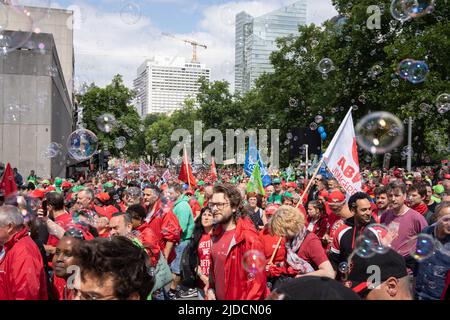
[235,0,307,93]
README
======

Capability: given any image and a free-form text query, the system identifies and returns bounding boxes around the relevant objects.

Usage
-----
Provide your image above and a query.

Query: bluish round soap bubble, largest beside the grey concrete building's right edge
[67,129,98,161]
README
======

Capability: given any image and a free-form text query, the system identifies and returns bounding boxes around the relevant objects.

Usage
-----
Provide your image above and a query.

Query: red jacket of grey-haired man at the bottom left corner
[0,228,48,300]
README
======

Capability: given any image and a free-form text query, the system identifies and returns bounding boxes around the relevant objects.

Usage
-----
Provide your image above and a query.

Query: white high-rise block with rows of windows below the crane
[134,56,210,117]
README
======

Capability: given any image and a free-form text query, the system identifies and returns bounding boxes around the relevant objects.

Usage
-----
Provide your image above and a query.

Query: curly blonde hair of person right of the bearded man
[268,206,305,238]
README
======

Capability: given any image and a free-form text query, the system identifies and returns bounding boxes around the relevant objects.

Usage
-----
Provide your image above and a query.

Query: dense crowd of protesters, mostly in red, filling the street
[0,160,450,300]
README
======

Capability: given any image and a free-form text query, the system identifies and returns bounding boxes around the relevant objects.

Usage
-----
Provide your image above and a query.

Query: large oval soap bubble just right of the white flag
[355,111,404,153]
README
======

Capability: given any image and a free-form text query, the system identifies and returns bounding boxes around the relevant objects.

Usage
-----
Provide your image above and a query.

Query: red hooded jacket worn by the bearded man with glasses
[210,218,269,300]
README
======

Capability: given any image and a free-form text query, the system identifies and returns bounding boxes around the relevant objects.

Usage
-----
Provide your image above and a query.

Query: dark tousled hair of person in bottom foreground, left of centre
[77,236,154,300]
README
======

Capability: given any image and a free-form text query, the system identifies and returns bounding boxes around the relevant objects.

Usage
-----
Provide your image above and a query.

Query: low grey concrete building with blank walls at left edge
[0,33,72,177]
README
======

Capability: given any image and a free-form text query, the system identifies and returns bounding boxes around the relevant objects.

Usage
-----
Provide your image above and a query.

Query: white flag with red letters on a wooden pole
[323,108,361,199]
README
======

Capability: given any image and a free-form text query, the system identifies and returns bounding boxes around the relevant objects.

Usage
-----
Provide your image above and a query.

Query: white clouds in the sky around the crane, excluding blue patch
[70,0,336,91]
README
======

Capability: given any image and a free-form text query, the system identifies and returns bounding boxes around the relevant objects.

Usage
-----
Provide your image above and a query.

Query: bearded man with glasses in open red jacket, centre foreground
[207,184,268,300]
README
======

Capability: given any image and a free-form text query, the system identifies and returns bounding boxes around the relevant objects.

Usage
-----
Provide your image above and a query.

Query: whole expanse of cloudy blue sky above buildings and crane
[39,0,336,88]
